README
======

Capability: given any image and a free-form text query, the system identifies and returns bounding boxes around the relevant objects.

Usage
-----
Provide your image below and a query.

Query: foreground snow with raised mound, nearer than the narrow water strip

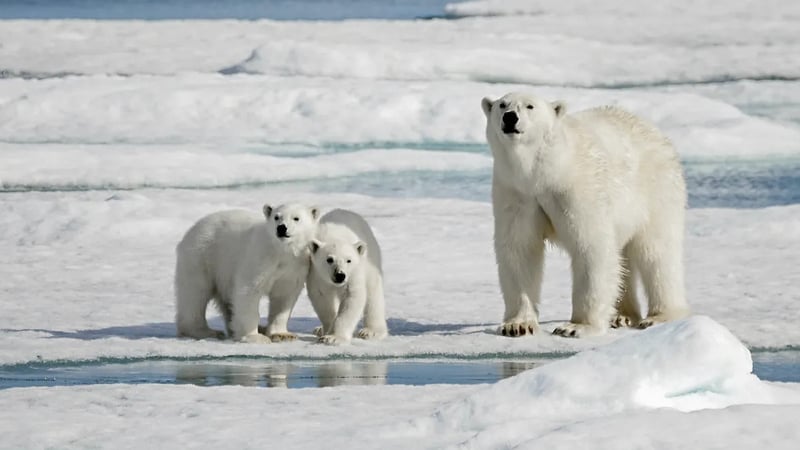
[0,316,800,449]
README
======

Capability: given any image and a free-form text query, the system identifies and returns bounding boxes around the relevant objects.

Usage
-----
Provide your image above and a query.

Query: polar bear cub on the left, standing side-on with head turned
[175,204,319,343]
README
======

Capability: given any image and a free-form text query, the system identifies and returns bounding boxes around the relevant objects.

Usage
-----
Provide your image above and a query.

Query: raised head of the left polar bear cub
[264,203,319,249]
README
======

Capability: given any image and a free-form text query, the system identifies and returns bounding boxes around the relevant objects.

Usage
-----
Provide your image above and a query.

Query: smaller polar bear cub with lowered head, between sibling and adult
[306,209,388,344]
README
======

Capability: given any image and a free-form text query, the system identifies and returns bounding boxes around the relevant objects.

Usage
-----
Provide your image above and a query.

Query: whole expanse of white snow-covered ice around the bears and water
[0,0,800,449]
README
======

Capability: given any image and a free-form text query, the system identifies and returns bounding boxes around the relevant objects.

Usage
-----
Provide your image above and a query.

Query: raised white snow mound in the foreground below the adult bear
[436,316,792,430]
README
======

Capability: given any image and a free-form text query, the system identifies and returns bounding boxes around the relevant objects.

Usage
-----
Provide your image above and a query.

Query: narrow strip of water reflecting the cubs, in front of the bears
[0,351,800,389]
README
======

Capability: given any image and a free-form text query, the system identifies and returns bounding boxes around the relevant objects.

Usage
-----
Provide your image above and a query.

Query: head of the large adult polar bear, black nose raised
[481,92,566,144]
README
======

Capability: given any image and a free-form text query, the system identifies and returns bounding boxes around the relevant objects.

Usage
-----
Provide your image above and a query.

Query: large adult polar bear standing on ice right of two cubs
[482,93,689,337]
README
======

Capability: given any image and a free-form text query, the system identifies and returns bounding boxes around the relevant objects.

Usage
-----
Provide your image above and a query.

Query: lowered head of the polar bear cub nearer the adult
[310,225,367,286]
